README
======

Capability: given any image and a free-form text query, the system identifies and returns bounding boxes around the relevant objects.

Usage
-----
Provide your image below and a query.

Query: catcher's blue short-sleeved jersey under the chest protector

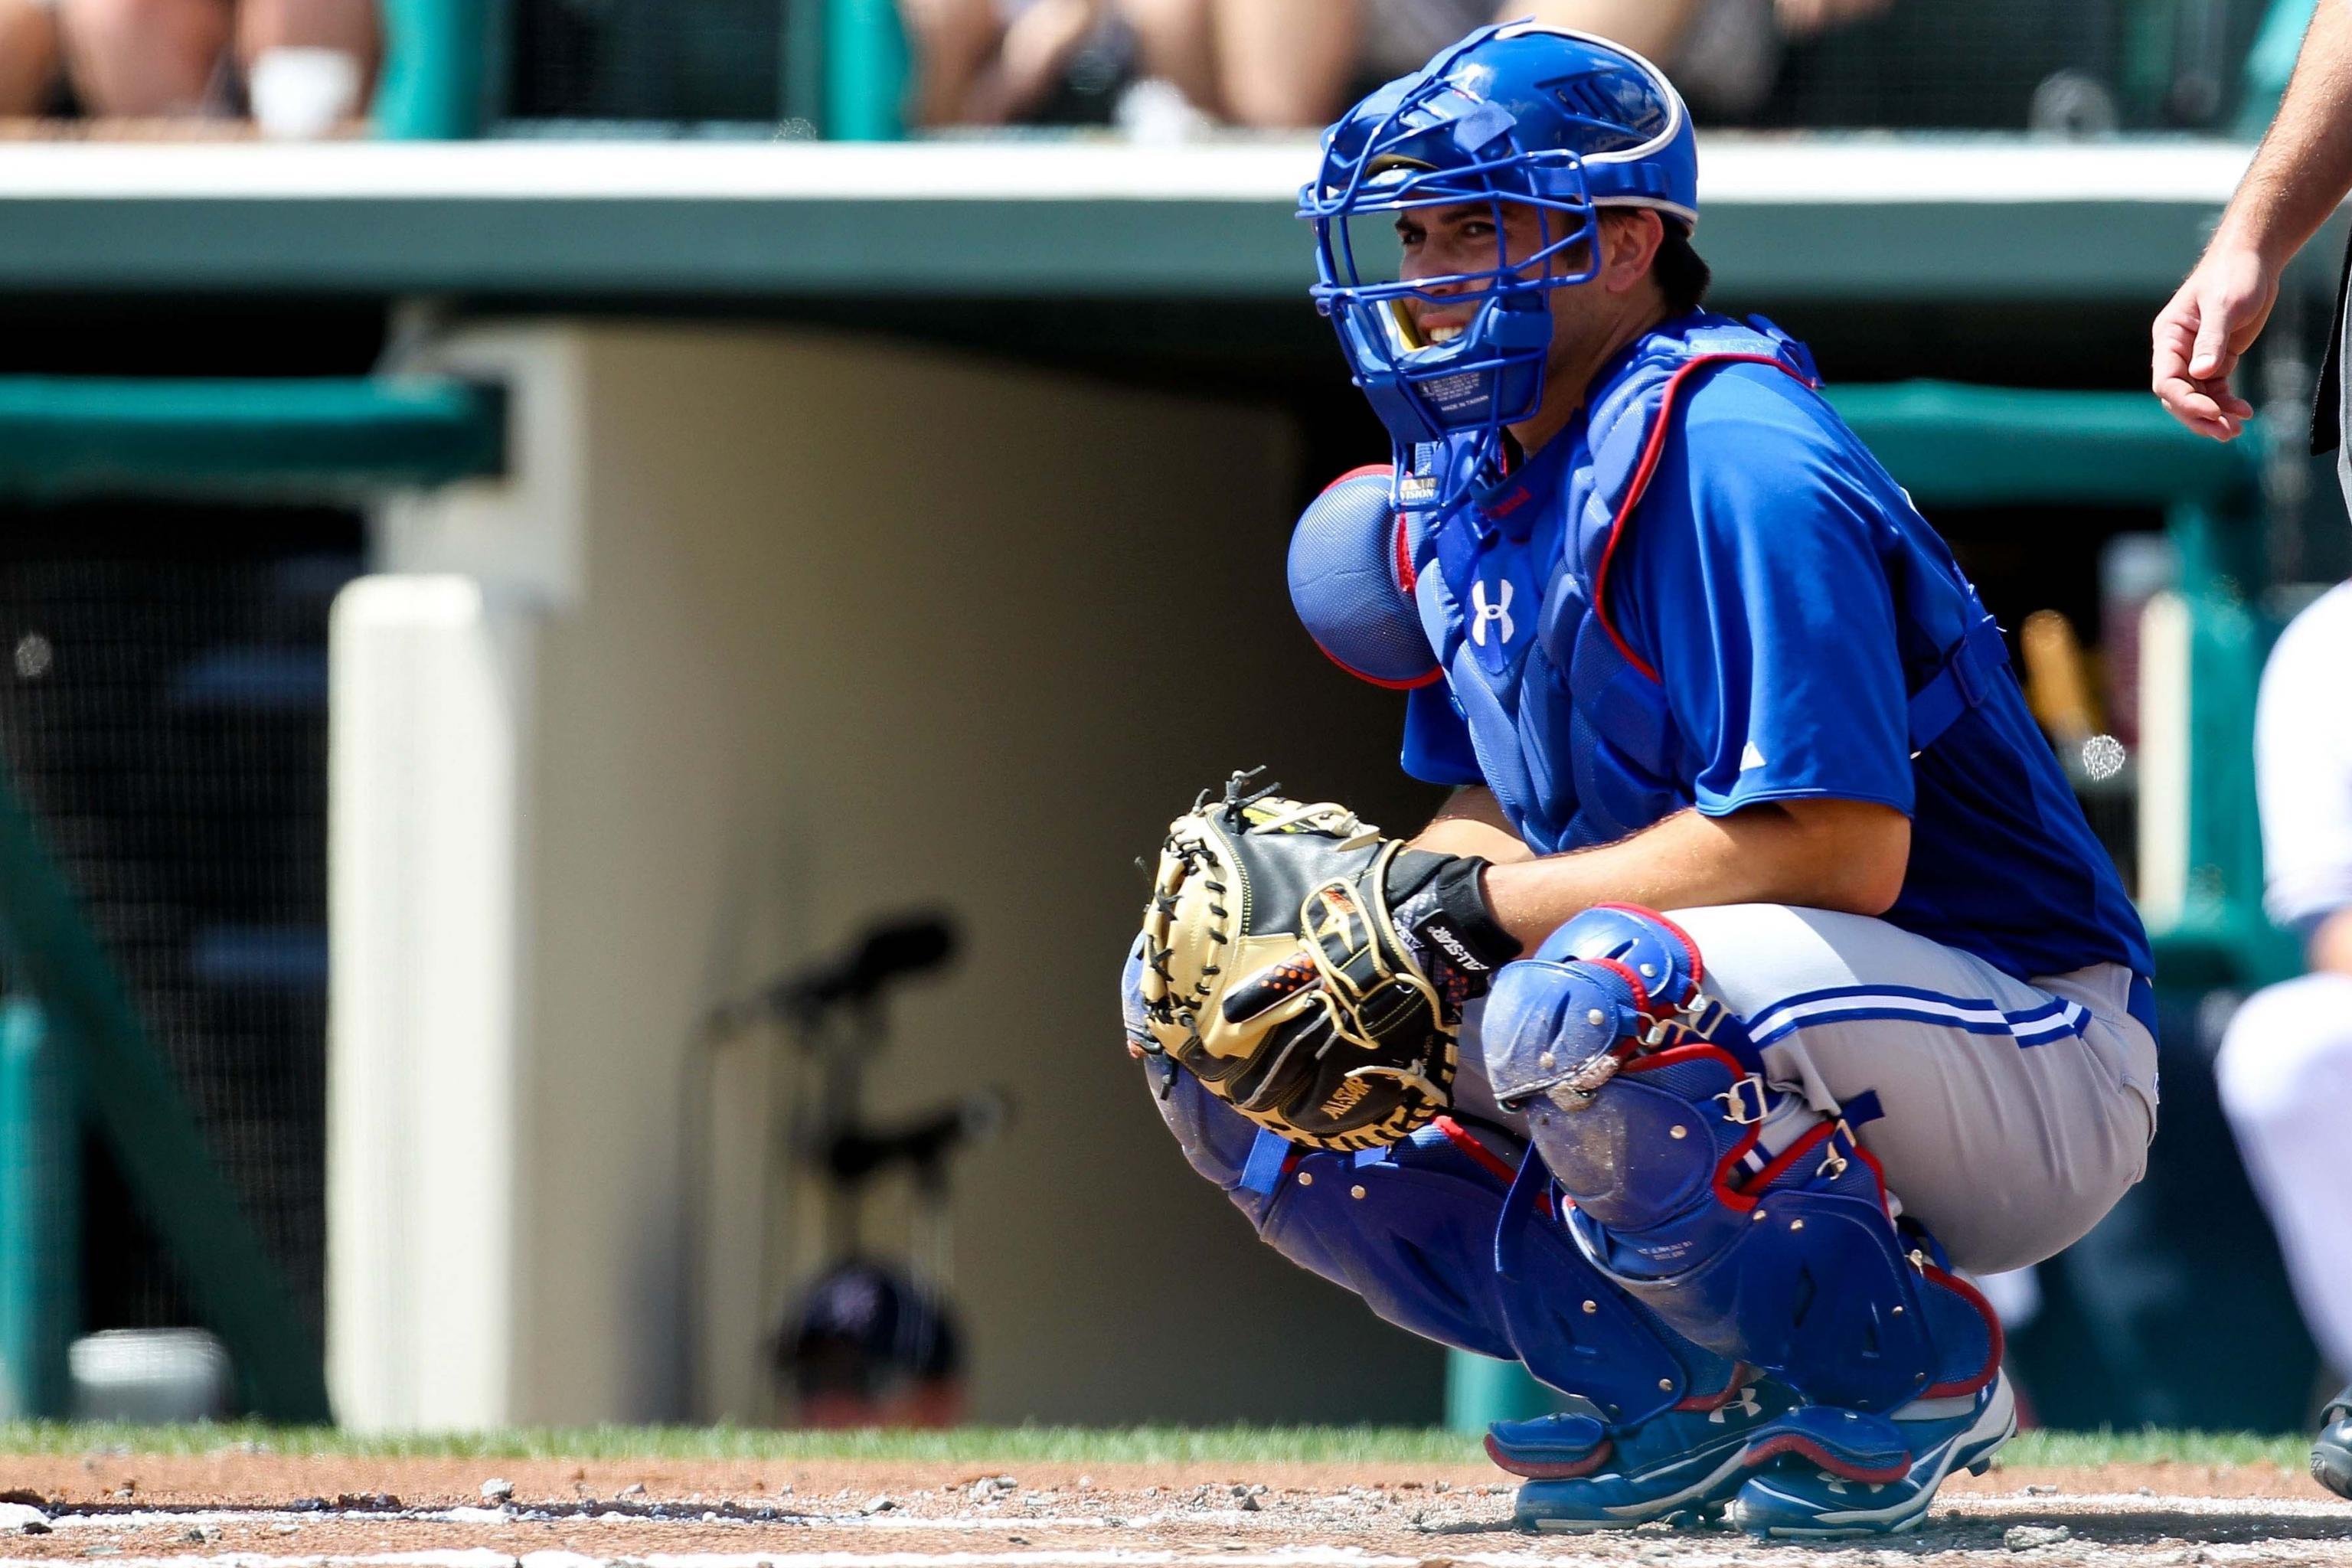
[1404,338,2152,978]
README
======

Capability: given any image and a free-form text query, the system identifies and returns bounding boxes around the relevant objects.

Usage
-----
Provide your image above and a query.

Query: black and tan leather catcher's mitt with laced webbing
[1138,773,1517,1149]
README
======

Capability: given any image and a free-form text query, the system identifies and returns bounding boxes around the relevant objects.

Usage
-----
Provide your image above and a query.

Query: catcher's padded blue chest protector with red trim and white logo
[1413,315,2006,854]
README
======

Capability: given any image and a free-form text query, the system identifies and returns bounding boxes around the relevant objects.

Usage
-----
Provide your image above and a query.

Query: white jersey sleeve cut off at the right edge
[2253,586,2352,936]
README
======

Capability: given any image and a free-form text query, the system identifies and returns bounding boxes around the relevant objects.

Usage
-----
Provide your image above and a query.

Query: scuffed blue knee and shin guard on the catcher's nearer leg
[1484,910,2001,1410]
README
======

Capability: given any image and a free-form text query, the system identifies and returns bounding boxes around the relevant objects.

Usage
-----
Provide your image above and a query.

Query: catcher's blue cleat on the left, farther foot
[1487,1375,1795,1530]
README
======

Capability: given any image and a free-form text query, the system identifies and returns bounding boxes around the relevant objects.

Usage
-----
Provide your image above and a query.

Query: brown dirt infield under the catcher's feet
[0,1450,2352,1568]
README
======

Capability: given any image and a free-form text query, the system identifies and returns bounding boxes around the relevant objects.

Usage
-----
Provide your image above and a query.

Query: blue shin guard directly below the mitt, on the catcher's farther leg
[1148,1058,1738,1474]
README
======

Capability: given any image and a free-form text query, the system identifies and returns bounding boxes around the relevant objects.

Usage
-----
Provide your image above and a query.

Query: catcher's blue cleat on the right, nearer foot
[1731,1373,2018,1540]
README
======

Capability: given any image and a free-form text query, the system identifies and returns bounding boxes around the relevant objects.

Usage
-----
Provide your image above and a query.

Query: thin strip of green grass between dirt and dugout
[0,1423,2308,1469]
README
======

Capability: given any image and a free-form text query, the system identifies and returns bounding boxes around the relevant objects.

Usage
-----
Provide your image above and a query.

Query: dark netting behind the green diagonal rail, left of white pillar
[0,505,360,1363]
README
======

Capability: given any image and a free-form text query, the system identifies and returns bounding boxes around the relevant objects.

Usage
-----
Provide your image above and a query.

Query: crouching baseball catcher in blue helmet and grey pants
[1122,24,2157,1537]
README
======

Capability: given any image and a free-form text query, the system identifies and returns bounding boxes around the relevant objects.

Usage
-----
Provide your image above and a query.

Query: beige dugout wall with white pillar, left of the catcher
[329,325,1442,1427]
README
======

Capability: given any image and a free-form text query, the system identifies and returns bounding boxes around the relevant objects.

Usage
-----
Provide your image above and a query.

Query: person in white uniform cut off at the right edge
[2213,583,2352,1495]
